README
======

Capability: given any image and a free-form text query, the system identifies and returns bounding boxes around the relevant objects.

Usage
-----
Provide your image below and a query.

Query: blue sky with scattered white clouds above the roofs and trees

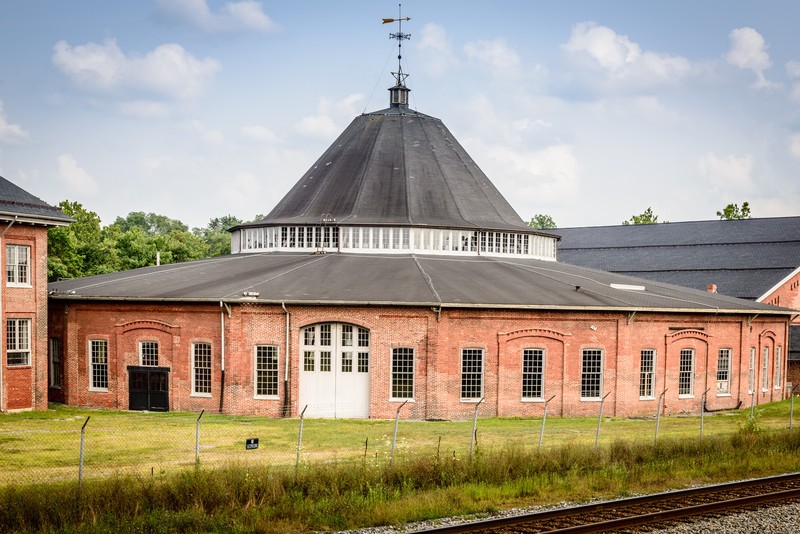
[0,0,800,228]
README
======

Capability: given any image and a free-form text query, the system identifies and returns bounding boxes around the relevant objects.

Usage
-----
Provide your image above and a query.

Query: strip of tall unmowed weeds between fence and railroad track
[0,427,800,532]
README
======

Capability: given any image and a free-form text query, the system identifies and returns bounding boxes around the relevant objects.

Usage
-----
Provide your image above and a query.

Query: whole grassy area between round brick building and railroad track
[0,401,800,533]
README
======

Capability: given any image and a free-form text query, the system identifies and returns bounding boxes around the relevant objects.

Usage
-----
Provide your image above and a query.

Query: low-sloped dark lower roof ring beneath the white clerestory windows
[49,252,792,314]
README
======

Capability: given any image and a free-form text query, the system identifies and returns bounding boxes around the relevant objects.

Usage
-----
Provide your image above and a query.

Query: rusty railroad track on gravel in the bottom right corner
[430,473,800,534]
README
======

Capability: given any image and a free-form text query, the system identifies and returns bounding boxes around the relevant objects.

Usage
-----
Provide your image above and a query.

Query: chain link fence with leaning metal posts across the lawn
[0,398,796,485]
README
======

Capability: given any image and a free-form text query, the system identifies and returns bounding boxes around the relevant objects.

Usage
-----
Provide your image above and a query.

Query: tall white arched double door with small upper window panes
[298,323,370,419]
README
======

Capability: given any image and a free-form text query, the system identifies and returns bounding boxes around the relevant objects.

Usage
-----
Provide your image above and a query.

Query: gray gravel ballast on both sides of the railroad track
[340,502,800,534]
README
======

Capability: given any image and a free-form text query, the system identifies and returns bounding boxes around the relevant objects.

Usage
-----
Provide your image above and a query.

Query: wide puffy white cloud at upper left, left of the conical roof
[53,39,220,98]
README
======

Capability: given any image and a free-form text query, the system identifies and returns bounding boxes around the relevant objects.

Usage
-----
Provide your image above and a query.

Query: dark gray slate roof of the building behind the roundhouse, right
[553,217,800,300]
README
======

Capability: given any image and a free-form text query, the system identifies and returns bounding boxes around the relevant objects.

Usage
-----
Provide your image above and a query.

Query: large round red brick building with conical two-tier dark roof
[49,71,793,419]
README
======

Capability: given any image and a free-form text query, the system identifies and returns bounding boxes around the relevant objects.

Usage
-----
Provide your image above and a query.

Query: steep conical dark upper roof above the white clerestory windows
[245,107,539,233]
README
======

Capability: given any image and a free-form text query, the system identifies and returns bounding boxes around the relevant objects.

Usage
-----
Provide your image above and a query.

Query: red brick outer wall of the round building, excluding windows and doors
[50,300,788,419]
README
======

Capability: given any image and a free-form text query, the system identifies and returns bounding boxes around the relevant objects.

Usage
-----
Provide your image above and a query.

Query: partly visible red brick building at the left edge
[0,177,71,412]
